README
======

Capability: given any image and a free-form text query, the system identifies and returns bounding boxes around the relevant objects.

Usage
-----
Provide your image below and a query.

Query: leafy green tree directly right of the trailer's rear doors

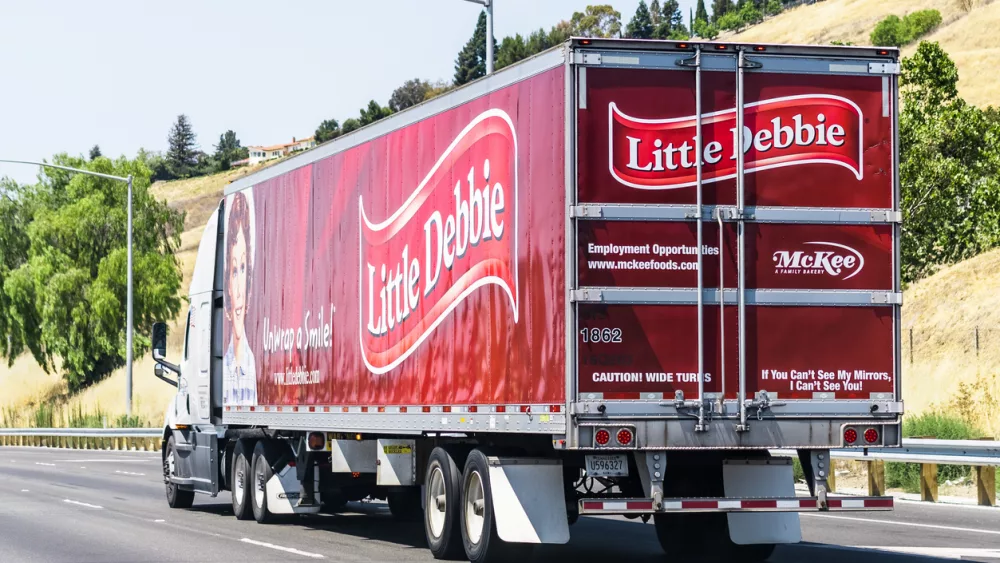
[899,41,1000,282]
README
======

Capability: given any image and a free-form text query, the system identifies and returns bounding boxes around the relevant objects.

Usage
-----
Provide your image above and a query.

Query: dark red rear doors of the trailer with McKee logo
[572,44,902,432]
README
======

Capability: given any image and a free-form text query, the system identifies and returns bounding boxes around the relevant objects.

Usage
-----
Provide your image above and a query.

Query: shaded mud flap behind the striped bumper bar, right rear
[722,458,802,545]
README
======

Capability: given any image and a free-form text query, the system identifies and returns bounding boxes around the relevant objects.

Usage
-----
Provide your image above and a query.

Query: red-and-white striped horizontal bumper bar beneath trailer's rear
[580,497,893,515]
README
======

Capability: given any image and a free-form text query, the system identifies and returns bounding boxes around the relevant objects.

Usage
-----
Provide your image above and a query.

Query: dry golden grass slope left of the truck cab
[0,169,248,426]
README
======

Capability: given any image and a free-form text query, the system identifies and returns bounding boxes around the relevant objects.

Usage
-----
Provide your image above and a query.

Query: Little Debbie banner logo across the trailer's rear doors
[608,94,864,190]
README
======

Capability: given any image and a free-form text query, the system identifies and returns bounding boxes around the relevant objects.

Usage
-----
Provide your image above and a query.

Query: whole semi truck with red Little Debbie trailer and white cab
[152,38,903,562]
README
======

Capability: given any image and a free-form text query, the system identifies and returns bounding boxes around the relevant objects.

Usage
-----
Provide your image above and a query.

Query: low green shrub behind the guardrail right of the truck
[885,413,982,493]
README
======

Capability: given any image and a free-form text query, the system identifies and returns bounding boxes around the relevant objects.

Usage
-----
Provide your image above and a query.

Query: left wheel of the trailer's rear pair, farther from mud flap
[424,448,463,559]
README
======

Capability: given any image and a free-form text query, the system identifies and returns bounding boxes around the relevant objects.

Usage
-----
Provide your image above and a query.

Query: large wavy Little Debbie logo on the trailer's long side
[358,109,519,374]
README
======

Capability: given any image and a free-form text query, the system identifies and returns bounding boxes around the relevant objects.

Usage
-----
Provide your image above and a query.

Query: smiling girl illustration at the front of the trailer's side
[223,192,257,405]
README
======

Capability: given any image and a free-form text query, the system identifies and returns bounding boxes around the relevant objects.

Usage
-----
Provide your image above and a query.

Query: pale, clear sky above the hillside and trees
[0,0,696,182]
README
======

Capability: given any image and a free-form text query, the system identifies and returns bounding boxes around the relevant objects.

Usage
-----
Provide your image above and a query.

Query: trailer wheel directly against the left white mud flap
[462,450,534,563]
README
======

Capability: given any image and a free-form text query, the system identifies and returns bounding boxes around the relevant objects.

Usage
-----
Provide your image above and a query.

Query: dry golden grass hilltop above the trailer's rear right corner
[720,0,1000,106]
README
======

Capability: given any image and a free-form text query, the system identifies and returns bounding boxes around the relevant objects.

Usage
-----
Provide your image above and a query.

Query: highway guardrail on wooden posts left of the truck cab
[0,428,163,452]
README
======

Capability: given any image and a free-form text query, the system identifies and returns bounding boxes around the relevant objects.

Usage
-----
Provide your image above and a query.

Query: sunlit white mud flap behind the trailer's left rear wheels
[488,457,569,544]
